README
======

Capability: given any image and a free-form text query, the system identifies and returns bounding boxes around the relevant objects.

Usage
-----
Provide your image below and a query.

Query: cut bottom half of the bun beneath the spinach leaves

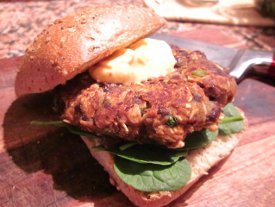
[82,135,239,207]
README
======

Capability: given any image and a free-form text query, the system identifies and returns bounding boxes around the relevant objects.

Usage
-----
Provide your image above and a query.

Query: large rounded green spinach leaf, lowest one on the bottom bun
[114,157,191,192]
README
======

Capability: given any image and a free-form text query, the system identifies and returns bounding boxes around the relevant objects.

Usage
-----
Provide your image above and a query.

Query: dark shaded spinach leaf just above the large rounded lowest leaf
[107,144,187,165]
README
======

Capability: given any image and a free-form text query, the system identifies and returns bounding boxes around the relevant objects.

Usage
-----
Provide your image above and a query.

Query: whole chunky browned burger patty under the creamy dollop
[58,47,236,148]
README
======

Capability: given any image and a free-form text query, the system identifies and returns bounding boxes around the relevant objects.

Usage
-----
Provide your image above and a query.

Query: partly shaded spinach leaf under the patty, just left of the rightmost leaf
[183,129,218,150]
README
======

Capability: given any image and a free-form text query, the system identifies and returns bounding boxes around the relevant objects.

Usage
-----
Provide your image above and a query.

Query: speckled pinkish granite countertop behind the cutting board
[0,0,275,58]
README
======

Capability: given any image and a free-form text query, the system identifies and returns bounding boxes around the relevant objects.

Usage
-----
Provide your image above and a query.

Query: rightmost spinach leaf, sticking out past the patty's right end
[219,103,244,136]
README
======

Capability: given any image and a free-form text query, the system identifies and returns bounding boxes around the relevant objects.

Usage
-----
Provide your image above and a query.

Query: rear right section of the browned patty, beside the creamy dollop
[173,47,237,105]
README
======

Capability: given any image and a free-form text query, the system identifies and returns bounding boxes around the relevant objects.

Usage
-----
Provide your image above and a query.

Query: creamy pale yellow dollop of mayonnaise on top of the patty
[89,38,176,84]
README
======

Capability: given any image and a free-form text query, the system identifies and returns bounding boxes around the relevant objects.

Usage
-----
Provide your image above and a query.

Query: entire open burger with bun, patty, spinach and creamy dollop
[15,5,244,207]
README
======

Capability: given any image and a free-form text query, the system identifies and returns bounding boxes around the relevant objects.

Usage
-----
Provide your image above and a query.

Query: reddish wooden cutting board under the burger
[0,55,275,207]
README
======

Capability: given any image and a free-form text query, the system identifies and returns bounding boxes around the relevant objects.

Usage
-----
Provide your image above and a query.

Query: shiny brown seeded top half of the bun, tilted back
[15,5,164,96]
